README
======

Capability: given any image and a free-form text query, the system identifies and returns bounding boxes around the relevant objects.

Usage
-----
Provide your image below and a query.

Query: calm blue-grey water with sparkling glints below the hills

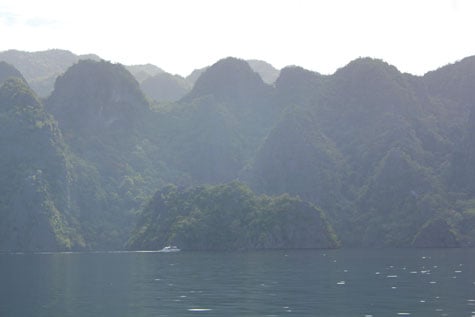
[0,249,475,317]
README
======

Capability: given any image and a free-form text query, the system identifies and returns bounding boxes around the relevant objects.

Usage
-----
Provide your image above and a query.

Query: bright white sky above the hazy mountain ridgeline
[0,0,475,76]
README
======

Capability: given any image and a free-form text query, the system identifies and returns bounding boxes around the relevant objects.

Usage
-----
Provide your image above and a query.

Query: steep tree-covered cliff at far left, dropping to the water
[0,79,84,251]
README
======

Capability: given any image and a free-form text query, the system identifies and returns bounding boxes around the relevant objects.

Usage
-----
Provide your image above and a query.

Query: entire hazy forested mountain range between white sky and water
[0,50,475,250]
